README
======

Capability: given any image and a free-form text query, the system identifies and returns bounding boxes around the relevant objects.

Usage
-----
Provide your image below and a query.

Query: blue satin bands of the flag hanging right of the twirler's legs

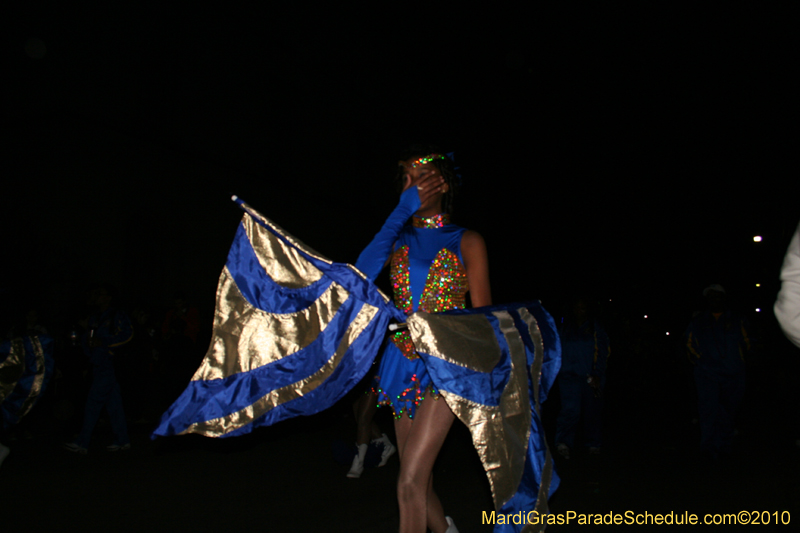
[420,302,561,533]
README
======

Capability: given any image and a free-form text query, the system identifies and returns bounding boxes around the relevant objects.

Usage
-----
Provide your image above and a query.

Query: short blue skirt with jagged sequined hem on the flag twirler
[372,341,439,418]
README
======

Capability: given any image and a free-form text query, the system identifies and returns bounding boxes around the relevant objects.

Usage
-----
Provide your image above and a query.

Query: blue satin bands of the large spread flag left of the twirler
[152,205,405,438]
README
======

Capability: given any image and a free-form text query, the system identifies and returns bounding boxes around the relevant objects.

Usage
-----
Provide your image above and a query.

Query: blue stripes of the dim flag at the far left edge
[0,335,55,430]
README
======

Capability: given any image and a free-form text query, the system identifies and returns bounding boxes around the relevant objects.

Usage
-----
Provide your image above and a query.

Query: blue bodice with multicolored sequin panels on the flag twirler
[390,217,469,359]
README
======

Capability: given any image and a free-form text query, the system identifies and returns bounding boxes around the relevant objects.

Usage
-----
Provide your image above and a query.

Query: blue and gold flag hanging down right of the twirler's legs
[408,302,561,532]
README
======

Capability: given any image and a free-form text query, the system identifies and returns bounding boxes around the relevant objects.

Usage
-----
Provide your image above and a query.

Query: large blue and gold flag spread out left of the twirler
[153,200,404,437]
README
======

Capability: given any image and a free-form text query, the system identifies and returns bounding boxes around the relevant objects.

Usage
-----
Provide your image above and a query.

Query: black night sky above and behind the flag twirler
[0,3,800,328]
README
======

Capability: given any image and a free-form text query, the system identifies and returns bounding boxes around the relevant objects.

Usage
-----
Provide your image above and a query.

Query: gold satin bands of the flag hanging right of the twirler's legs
[408,311,546,510]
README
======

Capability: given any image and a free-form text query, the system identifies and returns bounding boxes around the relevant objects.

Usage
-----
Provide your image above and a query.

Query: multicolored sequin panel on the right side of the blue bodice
[419,248,469,313]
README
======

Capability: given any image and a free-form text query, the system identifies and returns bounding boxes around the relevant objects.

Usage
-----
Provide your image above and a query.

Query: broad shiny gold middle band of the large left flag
[192,267,348,381]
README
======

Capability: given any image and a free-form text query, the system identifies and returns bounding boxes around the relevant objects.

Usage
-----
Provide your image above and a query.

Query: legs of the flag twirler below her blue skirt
[395,396,455,533]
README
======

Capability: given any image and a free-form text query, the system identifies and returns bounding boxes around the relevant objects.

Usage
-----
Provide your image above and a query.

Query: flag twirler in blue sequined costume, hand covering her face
[360,147,491,533]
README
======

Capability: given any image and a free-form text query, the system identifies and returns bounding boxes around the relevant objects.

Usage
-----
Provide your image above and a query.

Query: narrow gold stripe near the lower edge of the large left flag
[180,303,378,437]
